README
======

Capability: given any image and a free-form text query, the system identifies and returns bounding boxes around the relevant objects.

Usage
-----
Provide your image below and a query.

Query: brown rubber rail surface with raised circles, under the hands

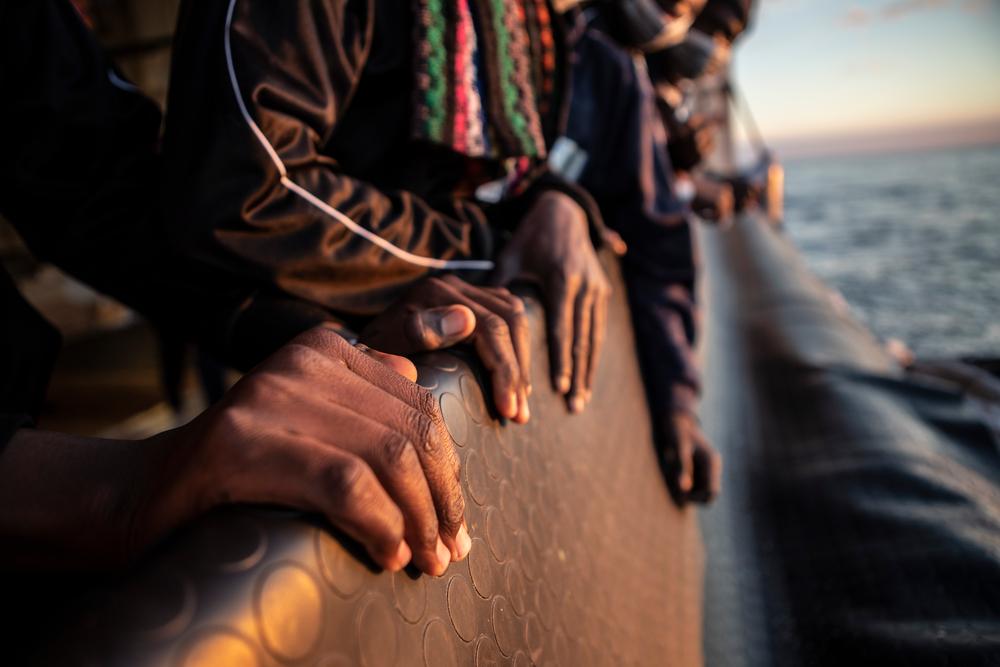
[33,258,703,667]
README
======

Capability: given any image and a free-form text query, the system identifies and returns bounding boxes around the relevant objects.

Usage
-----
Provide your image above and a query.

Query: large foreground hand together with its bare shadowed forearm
[0,327,471,576]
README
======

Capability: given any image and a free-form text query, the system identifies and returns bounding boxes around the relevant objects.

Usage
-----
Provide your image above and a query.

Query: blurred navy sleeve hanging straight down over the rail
[567,30,699,410]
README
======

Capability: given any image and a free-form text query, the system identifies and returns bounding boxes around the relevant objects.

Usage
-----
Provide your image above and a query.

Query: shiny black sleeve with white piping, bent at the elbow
[164,0,500,315]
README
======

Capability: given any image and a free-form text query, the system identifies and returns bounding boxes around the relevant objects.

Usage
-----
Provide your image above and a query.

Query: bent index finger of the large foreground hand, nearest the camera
[226,432,411,572]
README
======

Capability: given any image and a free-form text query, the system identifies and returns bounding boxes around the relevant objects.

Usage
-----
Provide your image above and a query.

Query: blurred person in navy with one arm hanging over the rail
[555,2,722,504]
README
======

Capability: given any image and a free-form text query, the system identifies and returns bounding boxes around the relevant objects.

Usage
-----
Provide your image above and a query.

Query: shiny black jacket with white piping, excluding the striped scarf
[163,0,599,316]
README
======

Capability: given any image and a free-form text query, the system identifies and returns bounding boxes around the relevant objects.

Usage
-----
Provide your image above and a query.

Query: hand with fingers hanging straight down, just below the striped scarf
[493,192,611,412]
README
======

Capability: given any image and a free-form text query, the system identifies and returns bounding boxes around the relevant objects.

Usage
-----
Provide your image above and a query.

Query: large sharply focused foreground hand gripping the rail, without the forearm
[131,327,471,575]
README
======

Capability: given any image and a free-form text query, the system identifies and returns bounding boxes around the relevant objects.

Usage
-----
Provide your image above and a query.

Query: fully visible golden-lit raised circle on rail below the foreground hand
[254,564,323,660]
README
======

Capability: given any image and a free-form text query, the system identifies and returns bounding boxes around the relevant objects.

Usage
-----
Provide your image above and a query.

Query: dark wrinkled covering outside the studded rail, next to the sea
[700,218,1000,667]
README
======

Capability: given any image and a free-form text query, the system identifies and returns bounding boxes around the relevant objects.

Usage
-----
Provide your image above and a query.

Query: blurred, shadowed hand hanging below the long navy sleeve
[657,411,722,506]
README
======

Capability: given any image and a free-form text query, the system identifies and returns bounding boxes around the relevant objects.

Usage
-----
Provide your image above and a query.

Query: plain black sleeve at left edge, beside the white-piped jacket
[0,0,262,350]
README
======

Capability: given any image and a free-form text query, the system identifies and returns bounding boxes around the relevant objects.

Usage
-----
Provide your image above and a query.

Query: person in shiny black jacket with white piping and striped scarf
[163,0,610,422]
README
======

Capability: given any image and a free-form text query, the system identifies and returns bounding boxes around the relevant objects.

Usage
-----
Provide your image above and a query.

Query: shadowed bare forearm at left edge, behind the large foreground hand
[0,429,186,570]
